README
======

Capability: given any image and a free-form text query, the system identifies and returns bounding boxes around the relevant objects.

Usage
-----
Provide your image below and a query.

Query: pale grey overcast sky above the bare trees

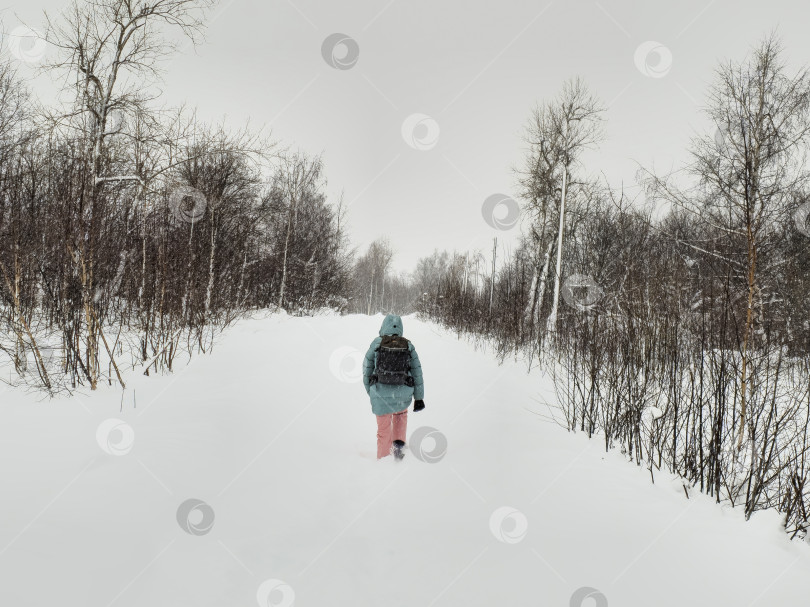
[2,0,810,271]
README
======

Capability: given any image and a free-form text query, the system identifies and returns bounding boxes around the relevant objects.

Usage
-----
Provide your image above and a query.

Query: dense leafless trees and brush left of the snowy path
[0,0,351,392]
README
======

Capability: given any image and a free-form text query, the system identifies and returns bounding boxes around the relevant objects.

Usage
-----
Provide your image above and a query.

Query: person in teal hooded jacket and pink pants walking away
[363,314,425,460]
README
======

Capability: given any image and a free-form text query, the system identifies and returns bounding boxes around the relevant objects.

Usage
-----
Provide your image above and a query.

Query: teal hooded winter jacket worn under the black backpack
[363,314,425,415]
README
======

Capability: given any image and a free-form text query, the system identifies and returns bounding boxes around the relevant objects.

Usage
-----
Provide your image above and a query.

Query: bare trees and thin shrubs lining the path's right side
[420,37,810,537]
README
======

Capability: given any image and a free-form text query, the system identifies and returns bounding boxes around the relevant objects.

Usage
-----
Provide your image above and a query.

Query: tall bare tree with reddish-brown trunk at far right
[653,35,810,448]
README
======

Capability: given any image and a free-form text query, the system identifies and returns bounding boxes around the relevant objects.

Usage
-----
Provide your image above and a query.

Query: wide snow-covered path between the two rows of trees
[0,316,810,607]
